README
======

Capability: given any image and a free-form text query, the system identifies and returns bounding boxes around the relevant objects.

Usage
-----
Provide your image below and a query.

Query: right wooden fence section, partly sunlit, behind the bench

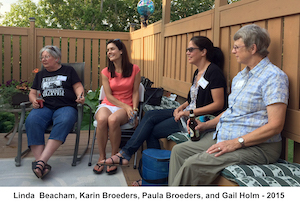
[130,0,300,163]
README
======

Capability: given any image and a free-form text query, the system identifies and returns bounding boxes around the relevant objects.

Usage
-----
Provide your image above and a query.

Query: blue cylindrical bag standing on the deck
[139,149,171,186]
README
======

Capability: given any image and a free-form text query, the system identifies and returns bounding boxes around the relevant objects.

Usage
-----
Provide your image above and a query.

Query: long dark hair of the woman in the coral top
[106,39,133,78]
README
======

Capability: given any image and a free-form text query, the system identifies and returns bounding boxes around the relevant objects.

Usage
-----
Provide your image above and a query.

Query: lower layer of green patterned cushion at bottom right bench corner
[235,176,300,187]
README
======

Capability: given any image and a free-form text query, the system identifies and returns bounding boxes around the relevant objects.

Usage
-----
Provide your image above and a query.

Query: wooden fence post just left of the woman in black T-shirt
[27,17,37,79]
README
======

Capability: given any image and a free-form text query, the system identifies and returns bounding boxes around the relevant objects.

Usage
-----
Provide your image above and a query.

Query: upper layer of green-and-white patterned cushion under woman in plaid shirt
[221,163,300,181]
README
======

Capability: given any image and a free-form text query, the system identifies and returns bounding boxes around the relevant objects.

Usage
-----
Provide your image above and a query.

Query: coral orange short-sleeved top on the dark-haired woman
[101,64,140,107]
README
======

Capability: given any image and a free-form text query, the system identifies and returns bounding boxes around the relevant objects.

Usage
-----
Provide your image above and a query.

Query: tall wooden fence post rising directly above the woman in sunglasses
[212,0,228,47]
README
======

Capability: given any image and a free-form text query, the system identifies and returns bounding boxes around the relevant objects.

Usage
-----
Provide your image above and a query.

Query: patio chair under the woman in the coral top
[88,83,145,169]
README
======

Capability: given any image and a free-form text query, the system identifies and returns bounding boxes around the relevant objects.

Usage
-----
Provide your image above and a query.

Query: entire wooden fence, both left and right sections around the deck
[0,0,300,162]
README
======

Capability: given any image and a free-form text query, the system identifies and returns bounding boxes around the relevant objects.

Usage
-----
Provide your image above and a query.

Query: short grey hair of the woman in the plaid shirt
[233,24,271,58]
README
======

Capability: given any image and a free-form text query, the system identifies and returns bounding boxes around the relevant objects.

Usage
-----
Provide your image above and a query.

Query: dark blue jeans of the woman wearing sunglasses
[120,109,181,161]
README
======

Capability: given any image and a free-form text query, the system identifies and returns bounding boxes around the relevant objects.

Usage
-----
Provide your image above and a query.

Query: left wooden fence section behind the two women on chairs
[0,20,130,90]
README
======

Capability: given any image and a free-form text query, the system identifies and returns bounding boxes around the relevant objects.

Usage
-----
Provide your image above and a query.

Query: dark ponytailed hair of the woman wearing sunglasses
[191,36,224,70]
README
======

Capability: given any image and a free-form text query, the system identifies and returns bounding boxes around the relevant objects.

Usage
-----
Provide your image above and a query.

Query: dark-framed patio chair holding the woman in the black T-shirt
[15,62,92,167]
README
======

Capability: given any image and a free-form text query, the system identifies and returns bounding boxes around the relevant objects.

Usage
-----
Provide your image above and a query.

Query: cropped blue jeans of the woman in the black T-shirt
[25,106,78,147]
